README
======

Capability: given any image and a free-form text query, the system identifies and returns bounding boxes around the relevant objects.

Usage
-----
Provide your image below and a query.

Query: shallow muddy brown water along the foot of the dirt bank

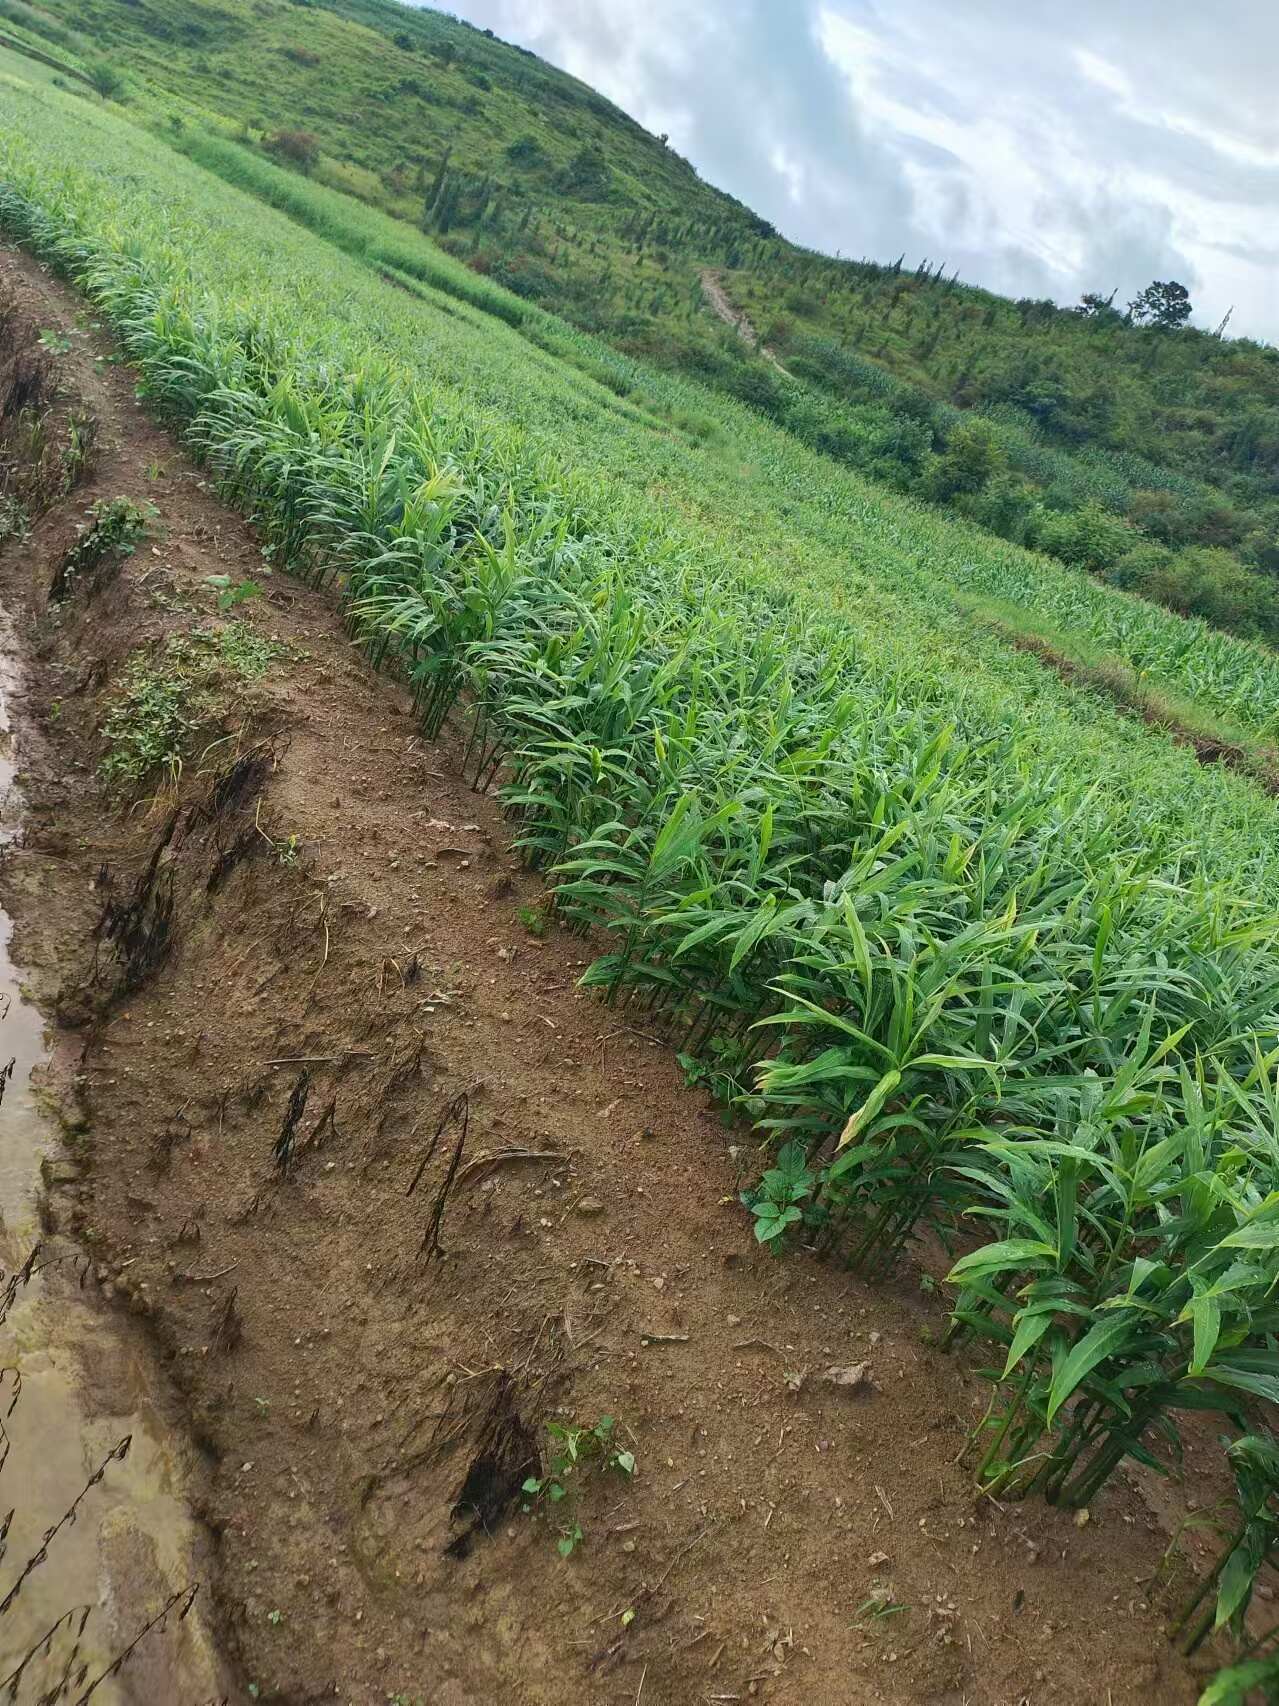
[0,633,229,1706]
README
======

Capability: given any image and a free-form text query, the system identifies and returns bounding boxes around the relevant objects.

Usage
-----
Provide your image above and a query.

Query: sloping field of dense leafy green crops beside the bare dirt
[0,60,1279,1685]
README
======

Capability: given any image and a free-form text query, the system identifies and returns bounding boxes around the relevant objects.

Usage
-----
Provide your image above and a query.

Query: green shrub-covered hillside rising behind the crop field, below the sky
[15,0,1279,641]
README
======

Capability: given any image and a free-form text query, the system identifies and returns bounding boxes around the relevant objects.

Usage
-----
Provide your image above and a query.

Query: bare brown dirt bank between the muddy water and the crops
[0,243,1255,1706]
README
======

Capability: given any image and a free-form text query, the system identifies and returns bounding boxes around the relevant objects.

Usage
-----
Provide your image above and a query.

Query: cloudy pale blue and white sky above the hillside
[431,0,1279,343]
